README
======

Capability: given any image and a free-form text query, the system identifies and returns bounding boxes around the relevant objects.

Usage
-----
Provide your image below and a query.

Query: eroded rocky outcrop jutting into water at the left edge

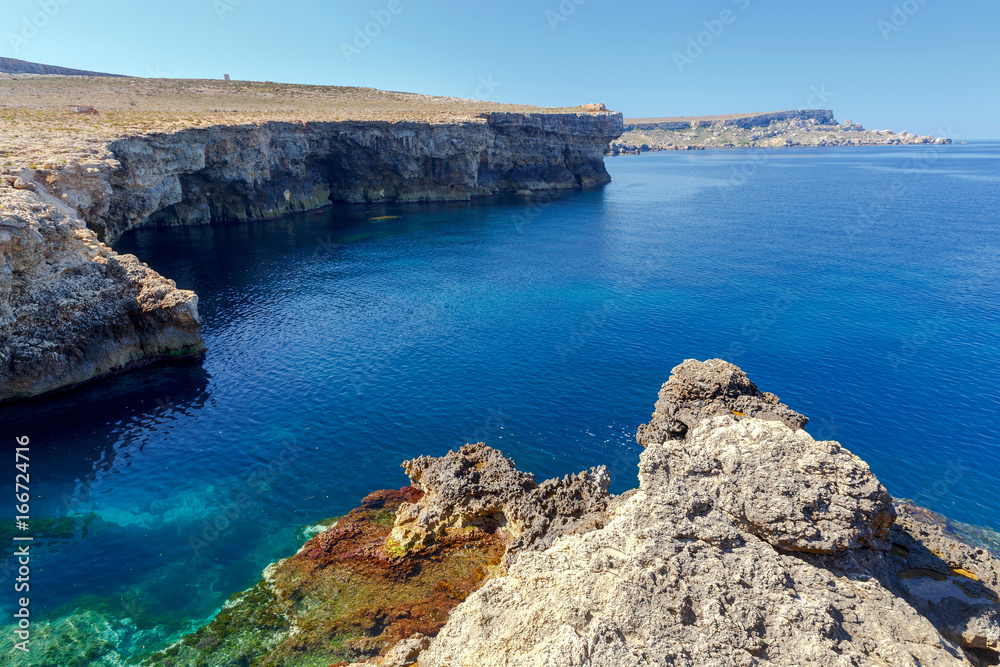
[0,183,204,400]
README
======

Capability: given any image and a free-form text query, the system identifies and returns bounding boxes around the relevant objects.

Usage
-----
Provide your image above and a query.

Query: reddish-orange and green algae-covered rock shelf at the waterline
[146,486,504,667]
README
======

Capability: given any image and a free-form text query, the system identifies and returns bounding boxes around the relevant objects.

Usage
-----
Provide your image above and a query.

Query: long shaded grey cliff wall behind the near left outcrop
[40,112,621,243]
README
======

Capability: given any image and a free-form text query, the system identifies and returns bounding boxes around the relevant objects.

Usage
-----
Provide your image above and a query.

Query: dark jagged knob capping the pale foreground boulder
[636,359,809,447]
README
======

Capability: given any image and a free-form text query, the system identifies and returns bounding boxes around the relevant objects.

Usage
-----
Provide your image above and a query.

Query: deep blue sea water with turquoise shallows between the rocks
[0,143,1000,660]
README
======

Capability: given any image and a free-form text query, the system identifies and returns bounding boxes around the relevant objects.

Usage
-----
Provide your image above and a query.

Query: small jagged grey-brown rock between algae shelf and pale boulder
[389,443,610,563]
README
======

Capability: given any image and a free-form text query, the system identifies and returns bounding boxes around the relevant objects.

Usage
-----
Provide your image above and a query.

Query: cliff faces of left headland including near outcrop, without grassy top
[0,111,622,400]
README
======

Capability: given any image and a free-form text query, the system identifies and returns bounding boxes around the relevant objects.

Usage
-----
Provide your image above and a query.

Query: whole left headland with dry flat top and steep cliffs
[0,74,622,401]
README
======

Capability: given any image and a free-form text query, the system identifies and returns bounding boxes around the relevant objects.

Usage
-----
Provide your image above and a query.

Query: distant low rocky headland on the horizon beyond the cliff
[608,109,951,155]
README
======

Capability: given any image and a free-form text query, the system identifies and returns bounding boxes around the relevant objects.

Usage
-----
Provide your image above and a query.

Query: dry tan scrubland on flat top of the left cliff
[0,74,604,172]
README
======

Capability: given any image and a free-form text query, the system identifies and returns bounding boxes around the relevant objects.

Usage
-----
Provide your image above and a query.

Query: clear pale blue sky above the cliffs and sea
[0,0,1000,139]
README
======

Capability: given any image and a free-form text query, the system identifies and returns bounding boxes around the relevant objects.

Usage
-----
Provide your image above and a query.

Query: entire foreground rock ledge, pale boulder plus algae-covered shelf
[150,359,1000,667]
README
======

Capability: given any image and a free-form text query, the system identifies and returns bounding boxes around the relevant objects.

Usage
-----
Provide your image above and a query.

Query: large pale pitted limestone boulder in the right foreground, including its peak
[419,361,1000,667]
